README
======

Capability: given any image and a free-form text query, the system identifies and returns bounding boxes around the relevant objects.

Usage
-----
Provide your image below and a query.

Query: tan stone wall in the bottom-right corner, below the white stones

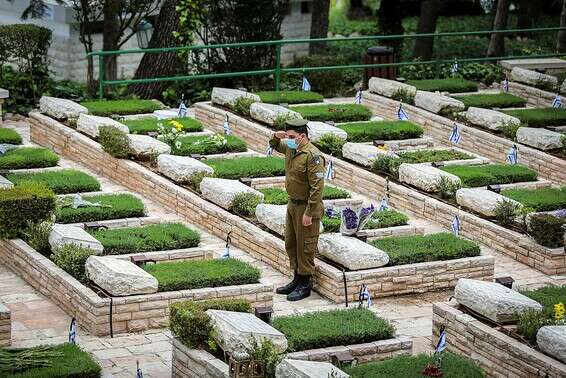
[432,302,566,378]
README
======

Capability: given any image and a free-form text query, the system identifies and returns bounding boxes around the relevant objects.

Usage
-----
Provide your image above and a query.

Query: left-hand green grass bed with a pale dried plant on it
[56,193,145,223]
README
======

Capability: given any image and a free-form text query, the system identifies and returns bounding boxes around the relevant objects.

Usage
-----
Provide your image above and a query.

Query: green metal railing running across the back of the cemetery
[87,27,566,98]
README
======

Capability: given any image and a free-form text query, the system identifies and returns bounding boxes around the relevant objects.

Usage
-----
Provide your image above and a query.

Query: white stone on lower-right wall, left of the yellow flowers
[454,278,542,323]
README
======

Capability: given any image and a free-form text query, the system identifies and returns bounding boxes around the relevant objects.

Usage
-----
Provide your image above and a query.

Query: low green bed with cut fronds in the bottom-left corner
[0,343,101,378]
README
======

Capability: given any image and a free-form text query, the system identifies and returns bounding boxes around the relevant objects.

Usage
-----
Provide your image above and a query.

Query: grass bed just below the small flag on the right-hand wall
[441,164,537,187]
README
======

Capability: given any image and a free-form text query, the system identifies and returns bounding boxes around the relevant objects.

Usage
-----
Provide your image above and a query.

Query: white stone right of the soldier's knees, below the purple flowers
[318,233,389,270]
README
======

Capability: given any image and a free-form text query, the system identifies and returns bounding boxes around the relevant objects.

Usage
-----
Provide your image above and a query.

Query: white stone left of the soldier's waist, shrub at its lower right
[200,177,263,210]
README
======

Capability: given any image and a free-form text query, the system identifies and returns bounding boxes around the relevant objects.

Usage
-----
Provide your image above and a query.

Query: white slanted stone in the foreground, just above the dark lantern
[206,310,287,354]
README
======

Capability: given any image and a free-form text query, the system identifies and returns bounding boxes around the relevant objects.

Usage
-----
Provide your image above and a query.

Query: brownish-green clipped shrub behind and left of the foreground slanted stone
[169,299,252,348]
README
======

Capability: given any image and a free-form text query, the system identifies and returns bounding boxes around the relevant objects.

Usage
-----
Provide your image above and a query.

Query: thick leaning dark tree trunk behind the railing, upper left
[133,0,182,98]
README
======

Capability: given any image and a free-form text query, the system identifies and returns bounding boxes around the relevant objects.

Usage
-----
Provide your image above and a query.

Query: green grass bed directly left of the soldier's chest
[203,156,285,180]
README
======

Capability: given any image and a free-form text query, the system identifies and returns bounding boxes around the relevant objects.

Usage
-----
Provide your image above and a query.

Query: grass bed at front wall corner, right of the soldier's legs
[370,232,480,266]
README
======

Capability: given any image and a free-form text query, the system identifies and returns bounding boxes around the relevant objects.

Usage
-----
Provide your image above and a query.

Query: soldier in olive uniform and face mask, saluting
[269,119,325,301]
